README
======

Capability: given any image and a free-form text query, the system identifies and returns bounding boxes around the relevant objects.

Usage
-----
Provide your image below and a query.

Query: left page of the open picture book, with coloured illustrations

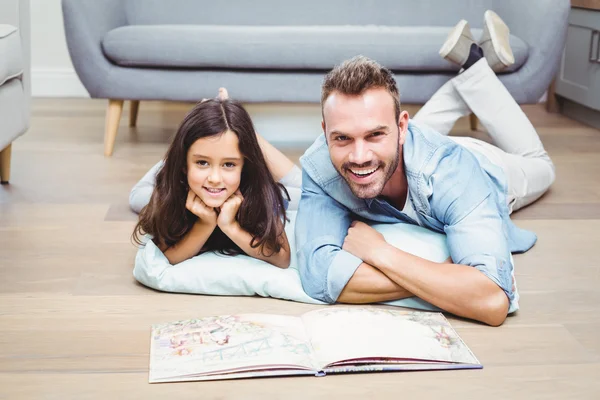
[150,314,314,382]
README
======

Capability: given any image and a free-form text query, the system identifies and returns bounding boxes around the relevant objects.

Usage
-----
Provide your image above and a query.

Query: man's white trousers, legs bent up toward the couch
[413,58,555,212]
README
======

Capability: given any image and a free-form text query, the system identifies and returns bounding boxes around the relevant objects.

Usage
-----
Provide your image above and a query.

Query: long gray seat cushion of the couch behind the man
[102,25,528,72]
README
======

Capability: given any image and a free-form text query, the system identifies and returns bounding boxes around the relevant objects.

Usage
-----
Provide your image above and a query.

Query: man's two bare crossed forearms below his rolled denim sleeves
[338,222,508,326]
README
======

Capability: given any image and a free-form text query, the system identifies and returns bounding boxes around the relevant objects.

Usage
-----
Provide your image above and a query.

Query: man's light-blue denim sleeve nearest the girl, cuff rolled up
[295,172,362,303]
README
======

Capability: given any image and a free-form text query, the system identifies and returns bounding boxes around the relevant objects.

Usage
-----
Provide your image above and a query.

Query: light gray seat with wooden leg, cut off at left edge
[0,0,31,183]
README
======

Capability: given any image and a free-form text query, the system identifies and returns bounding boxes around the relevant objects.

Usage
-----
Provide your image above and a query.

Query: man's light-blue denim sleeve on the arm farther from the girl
[430,150,517,312]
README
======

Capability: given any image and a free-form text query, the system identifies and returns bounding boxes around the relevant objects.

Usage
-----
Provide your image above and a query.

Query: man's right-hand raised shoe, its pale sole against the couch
[479,10,515,72]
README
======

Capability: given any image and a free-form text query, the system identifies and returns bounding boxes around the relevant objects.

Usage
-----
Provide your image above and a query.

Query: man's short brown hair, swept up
[321,56,400,122]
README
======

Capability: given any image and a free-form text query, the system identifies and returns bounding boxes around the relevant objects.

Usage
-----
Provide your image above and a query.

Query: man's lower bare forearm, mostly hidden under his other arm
[338,263,413,304]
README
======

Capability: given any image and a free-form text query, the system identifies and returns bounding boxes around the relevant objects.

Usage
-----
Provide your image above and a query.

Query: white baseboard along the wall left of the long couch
[31,68,90,98]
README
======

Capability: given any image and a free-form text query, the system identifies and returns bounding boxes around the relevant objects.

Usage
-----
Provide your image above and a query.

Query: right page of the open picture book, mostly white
[302,306,479,368]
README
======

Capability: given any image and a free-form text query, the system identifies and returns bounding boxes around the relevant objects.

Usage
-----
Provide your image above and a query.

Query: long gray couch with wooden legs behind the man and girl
[62,0,570,155]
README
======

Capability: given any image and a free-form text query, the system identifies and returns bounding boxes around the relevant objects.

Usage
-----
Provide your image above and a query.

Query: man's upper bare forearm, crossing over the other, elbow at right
[373,246,508,325]
